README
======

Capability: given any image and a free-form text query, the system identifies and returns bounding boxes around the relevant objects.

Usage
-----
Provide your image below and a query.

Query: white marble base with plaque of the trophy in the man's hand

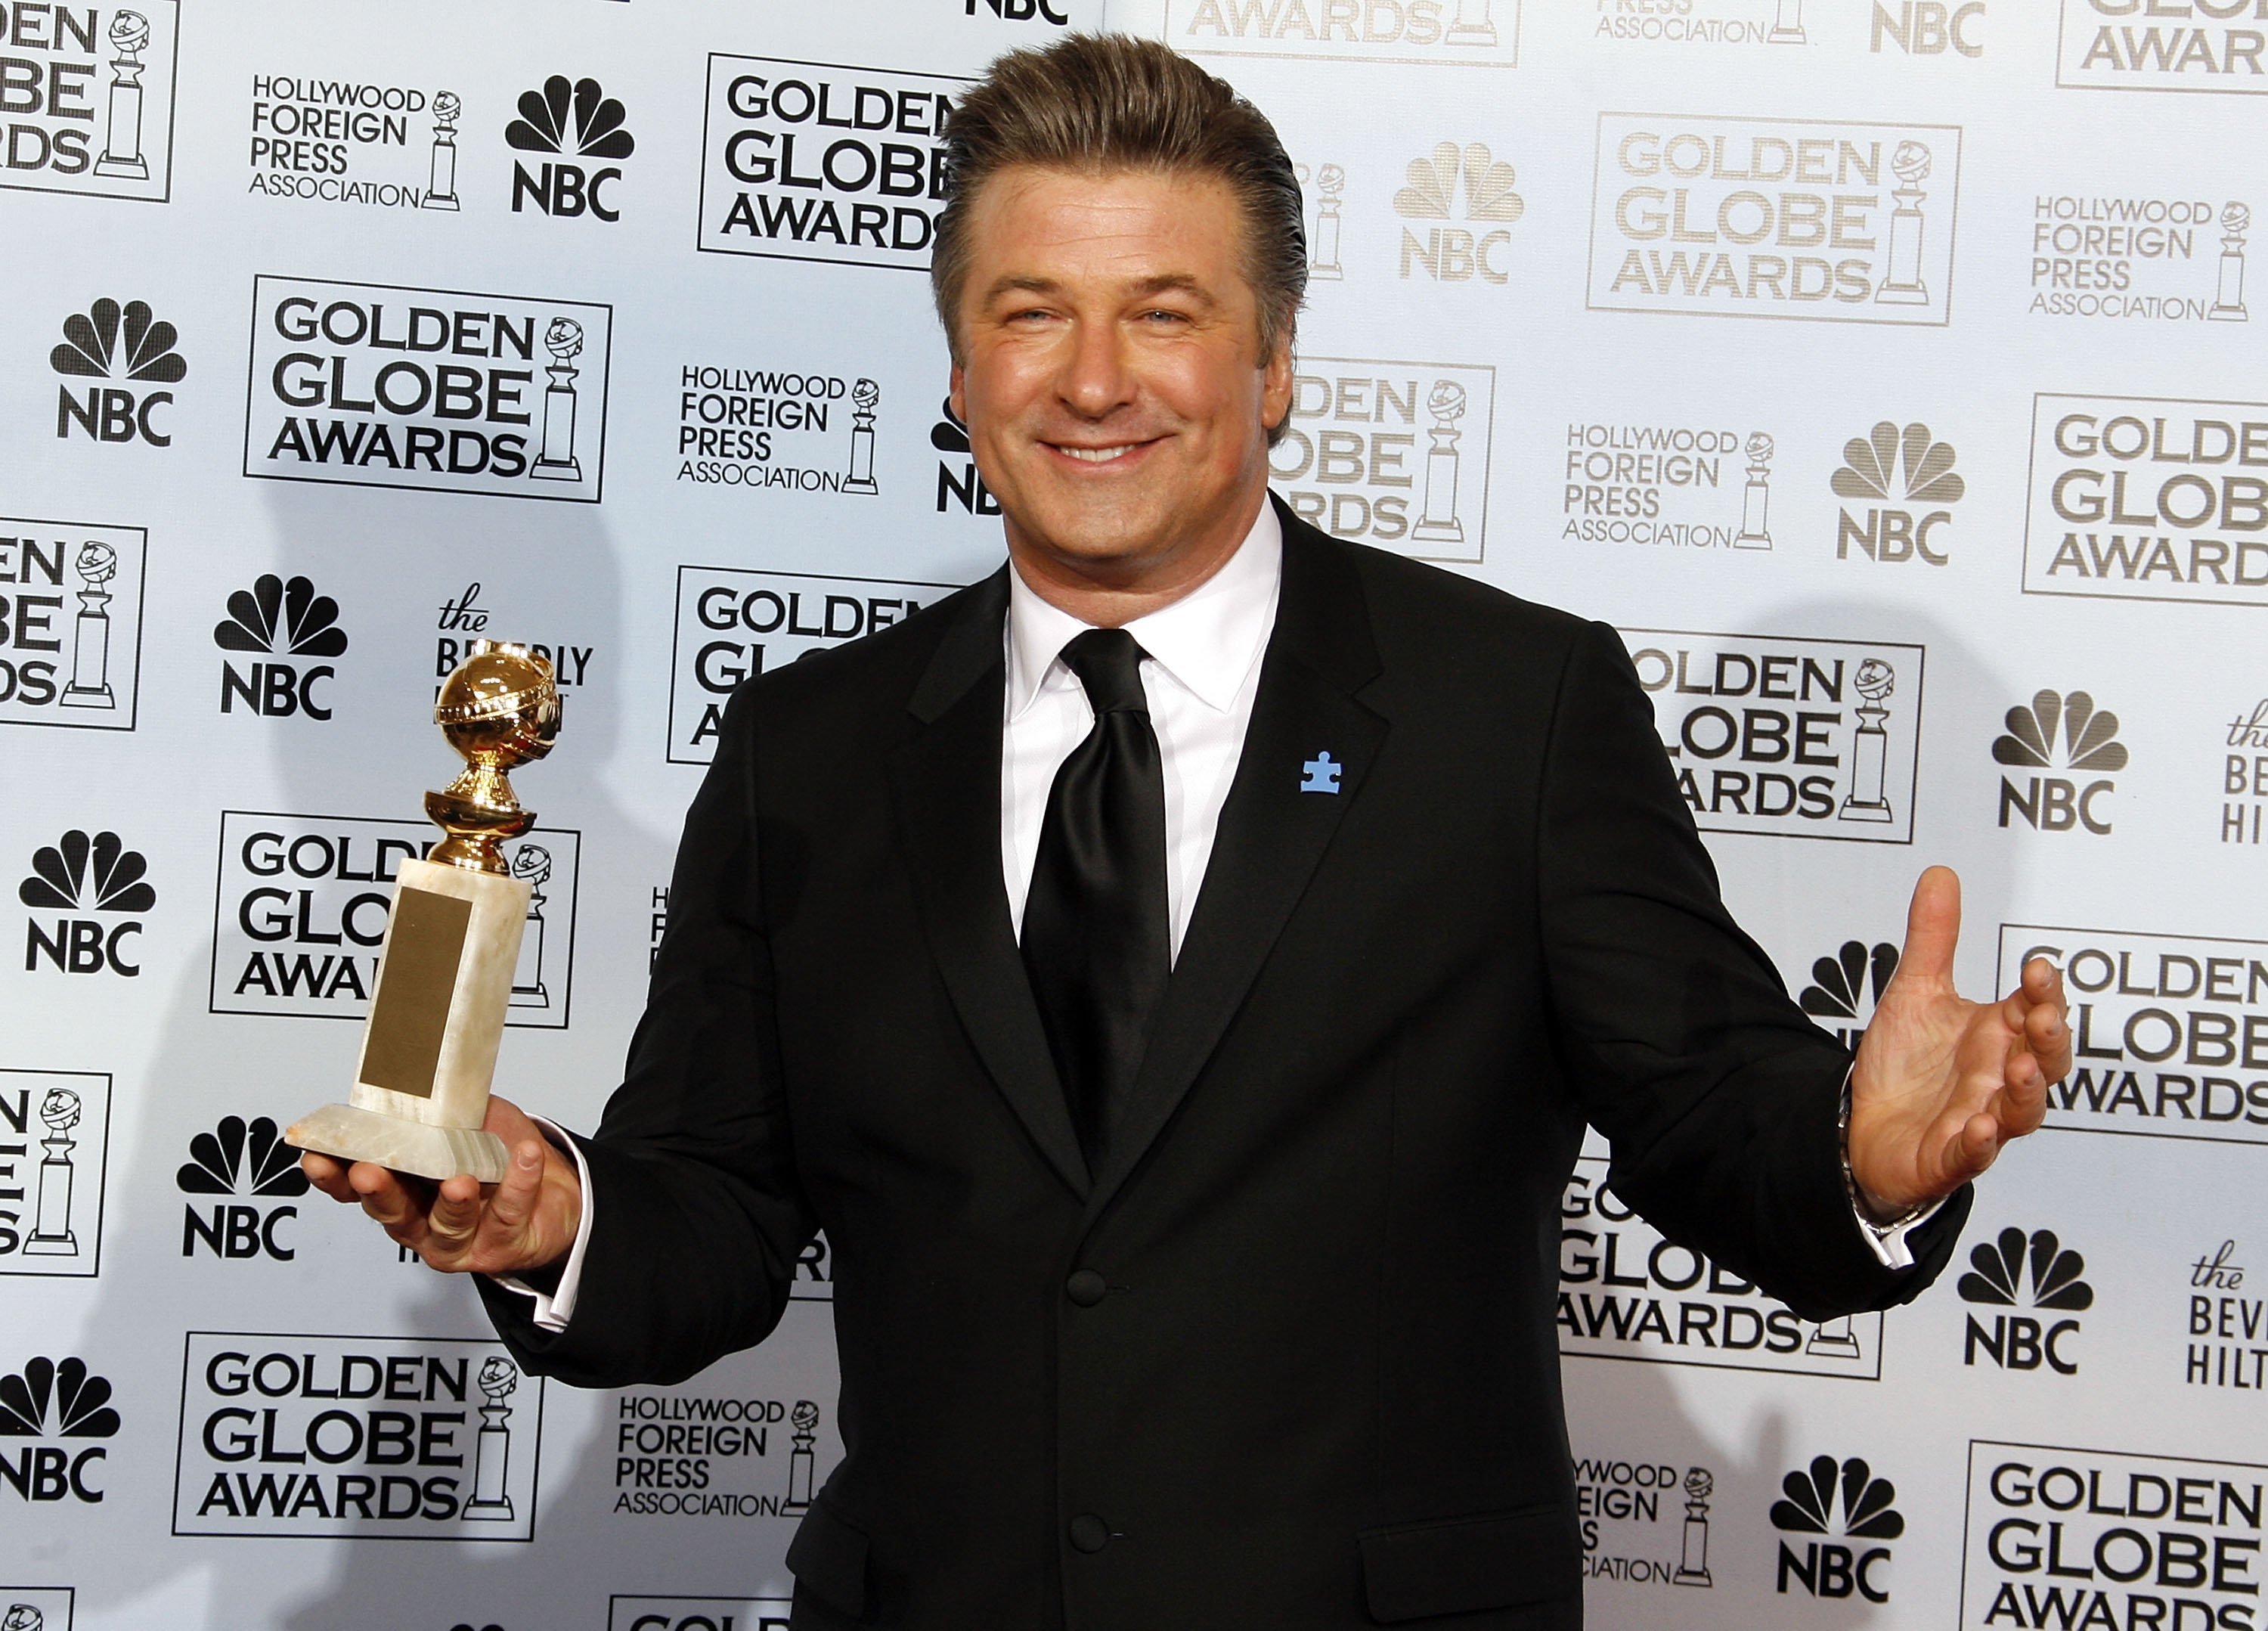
[284,860,531,1184]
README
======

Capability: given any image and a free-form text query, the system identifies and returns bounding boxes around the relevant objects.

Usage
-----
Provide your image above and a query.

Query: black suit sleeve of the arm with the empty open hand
[1538,624,1969,1320]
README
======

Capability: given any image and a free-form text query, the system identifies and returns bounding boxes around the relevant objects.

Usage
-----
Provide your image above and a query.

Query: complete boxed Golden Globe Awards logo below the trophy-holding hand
[172,1332,544,1540]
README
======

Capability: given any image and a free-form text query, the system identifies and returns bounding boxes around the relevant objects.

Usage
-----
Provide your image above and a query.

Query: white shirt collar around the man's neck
[1007,499,1284,719]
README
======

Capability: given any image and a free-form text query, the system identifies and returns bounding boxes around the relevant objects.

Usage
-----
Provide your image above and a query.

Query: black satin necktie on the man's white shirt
[1023,628,1170,1168]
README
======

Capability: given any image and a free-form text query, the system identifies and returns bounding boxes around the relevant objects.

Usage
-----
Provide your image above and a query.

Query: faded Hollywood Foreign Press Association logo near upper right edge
[2028,193,2252,322]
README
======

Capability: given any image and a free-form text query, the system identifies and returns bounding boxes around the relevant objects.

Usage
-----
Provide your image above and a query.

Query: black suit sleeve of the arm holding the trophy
[479,685,819,1388]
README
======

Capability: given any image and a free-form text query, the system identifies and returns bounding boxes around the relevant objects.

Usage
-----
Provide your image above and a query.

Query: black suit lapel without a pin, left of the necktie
[891,569,1089,1195]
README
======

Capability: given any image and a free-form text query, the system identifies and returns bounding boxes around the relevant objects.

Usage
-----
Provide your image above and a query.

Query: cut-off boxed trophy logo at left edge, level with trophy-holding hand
[0,1068,111,1279]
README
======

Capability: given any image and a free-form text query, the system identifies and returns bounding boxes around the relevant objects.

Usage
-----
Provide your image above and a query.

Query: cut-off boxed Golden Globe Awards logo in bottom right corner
[1944,1452,2268,1631]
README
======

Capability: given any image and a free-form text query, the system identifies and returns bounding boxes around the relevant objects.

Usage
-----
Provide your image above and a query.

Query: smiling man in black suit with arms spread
[308,39,2068,1631]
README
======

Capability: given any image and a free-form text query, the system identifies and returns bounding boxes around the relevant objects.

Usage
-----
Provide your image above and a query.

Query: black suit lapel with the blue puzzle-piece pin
[1089,510,1386,1216]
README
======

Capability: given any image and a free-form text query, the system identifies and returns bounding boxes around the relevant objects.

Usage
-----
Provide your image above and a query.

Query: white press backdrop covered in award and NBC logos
[0,0,2268,1631]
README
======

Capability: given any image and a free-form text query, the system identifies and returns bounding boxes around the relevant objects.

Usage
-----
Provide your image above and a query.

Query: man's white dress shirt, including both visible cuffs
[499,504,1935,1332]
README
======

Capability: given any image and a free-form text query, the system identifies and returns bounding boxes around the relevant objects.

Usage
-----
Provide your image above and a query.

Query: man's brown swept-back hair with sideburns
[930,34,1306,361]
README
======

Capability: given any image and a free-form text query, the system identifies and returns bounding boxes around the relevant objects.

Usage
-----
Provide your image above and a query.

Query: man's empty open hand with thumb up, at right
[1851,867,2071,1218]
